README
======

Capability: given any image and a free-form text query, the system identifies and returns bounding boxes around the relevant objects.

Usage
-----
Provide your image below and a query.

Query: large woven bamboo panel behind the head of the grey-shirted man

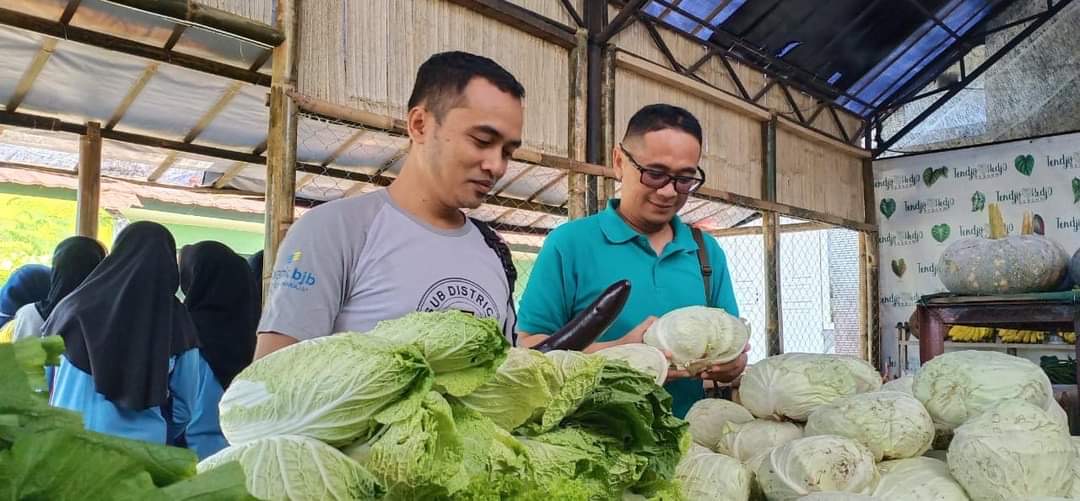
[298,0,570,157]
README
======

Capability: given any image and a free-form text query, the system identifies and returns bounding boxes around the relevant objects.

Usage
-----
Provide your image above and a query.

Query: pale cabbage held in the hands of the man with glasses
[645,306,750,374]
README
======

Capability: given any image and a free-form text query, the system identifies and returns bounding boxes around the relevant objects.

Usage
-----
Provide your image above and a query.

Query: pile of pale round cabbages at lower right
[676,351,1080,501]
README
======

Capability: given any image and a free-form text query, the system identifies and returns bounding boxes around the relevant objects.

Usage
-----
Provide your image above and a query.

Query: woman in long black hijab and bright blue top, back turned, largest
[42,221,206,444]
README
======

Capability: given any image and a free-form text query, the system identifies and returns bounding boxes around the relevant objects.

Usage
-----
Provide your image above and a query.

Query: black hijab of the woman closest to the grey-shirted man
[180,242,259,388]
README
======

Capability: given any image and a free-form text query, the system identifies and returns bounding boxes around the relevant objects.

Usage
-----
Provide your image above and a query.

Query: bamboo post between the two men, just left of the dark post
[565,29,589,219]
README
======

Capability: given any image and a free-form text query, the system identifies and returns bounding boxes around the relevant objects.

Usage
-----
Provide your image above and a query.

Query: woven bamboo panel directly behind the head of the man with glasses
[615,69,761,199]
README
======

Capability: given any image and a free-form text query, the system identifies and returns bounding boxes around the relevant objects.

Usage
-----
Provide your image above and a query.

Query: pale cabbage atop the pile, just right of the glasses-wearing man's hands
[739,353,881,421]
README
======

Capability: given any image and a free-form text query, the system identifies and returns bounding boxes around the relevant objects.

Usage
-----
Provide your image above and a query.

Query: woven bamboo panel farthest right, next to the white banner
[777,127,865,220]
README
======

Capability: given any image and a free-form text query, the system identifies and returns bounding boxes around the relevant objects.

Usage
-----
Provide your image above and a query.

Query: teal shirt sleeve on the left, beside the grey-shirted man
[517,230,572,334]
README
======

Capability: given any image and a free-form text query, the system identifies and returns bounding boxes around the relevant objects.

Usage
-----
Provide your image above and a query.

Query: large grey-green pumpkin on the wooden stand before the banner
[937,204,1069,296]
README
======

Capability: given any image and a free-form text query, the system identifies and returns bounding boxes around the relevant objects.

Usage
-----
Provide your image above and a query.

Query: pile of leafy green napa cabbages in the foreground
[199,312,689,500]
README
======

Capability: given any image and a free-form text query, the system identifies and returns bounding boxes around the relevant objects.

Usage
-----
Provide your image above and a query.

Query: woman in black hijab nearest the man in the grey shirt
[180,242,259,458]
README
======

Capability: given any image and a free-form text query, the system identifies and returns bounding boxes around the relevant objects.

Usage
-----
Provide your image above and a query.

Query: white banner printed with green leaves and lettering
[874,134,1080,374]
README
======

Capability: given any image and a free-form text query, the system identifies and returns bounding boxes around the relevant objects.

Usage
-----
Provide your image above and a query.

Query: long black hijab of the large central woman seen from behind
[42,221,195,410]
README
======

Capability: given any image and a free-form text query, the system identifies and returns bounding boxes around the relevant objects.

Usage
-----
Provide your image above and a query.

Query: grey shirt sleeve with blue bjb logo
[252,205,354,340]
